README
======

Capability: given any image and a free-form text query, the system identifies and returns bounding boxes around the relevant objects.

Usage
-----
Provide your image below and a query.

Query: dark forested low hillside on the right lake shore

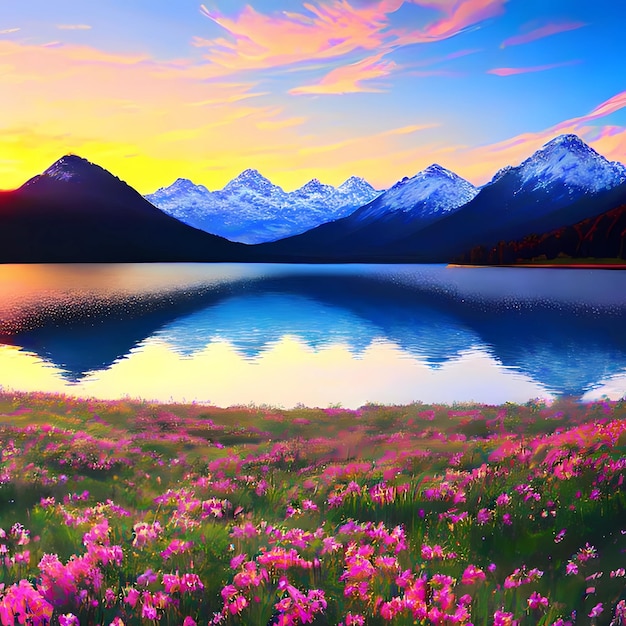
[456,204,626,265]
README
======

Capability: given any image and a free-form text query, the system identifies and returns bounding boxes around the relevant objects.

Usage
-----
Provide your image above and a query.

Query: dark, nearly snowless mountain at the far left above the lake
[0,155,254,263]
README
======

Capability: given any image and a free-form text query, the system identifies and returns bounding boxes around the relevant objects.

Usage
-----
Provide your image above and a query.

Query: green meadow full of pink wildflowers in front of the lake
[0,393,626,626]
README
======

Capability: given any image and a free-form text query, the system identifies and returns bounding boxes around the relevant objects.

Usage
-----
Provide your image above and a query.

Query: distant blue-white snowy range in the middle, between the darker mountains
[146,169,380,243]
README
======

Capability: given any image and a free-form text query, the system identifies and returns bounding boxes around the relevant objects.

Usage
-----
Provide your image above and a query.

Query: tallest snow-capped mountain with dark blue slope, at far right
[388,134,626,260]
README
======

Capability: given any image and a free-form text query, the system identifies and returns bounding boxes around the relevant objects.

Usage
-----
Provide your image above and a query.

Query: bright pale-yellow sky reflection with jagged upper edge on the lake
[0,337,550,408]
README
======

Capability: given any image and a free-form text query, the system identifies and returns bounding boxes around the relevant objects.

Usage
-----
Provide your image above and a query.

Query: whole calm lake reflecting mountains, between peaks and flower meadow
[0,264,626,408]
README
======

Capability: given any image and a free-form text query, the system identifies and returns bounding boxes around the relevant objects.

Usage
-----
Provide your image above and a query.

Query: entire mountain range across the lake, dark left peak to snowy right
[0,135,626,263]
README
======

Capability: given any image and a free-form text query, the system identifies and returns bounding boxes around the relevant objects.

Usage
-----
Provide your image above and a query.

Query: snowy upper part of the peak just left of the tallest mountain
[353,163,478,222]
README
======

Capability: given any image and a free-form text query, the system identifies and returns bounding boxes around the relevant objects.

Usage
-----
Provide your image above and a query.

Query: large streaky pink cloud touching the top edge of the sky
[193,0,507,80]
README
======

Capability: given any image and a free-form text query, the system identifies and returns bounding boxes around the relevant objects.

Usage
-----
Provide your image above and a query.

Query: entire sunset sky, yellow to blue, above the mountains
[0,0,626,193]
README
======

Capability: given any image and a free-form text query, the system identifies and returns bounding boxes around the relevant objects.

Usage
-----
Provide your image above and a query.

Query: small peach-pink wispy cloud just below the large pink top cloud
[289,54,398,95]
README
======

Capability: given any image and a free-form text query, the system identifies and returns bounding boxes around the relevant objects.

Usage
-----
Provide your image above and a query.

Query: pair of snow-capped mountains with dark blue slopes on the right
[259,135,626,263]
